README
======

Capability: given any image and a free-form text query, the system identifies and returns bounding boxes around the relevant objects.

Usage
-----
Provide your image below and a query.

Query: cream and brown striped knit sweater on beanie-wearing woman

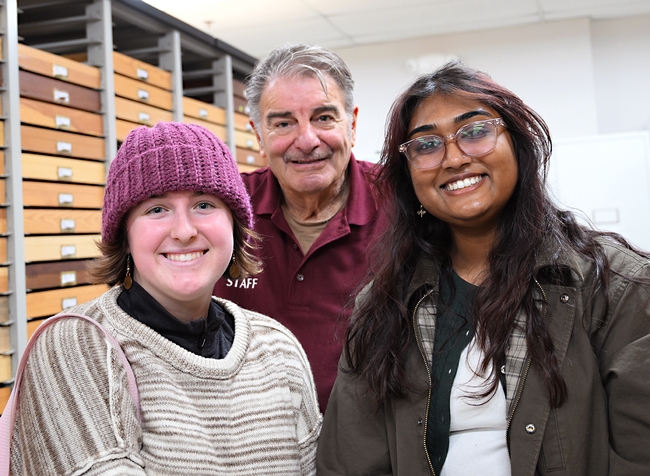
[11,287,321,476]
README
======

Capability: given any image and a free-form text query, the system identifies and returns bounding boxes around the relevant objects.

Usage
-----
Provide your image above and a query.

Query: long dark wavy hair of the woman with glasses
[344,63,638,407]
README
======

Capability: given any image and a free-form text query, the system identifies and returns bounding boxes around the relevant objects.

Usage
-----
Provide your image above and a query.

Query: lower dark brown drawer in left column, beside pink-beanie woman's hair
[25,260,90,291]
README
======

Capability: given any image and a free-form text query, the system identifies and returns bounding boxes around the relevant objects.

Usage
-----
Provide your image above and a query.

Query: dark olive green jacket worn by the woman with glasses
[317,243,650,476]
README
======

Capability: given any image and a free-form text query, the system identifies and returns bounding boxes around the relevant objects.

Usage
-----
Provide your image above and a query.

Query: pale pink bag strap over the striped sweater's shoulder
[0,314,142,476]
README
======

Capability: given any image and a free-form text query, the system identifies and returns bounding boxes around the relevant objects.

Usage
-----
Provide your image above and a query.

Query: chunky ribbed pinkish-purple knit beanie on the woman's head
[102,122,253,243]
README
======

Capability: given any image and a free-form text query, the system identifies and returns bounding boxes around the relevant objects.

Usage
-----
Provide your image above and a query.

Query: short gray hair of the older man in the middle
[246,43,354,130]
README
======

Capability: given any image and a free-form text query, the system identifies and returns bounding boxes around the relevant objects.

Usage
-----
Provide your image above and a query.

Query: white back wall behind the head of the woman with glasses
[336,16,650,164]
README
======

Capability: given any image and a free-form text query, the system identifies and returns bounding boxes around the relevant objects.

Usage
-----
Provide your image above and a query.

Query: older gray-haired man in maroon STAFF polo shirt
[215,44,386,411]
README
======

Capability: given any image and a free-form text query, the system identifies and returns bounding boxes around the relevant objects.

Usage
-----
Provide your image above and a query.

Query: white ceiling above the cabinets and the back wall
[145,0,650,57]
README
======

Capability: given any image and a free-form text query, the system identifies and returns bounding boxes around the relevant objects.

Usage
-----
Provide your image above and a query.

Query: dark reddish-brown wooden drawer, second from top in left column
[19,71,101,112]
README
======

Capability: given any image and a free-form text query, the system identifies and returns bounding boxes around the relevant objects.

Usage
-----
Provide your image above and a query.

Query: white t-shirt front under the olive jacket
[441,340,510,476]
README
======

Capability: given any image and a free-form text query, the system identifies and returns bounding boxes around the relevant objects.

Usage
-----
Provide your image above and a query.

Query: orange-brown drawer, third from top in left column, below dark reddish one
[20,98,104,136]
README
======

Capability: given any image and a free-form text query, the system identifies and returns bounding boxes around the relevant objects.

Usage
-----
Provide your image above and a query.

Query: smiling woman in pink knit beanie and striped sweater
[5,123,321,476]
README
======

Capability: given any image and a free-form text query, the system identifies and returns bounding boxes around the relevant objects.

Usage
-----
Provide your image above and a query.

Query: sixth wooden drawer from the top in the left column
[23,180,104,208]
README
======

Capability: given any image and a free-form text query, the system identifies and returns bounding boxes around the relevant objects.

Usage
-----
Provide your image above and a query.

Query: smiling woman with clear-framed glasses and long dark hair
[317,63,650,476]
